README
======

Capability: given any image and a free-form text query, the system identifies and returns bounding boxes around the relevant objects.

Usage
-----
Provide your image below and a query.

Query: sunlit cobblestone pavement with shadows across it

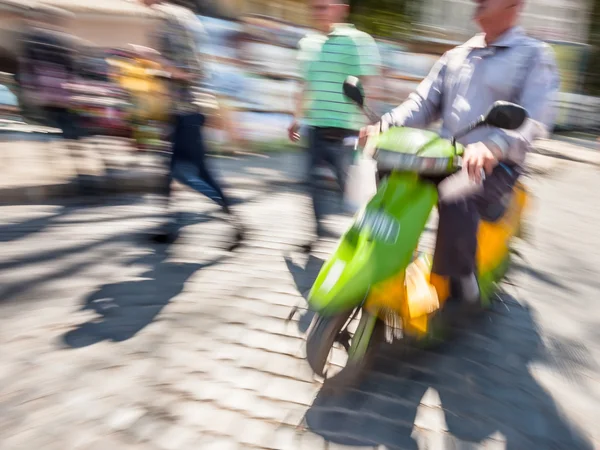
[0,153,600,450]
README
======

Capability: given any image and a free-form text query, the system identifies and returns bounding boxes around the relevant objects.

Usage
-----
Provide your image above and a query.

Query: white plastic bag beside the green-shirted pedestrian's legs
[344,155,377,213]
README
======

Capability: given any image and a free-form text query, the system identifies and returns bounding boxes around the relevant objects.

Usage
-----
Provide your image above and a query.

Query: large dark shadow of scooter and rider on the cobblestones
[305,298,593,450]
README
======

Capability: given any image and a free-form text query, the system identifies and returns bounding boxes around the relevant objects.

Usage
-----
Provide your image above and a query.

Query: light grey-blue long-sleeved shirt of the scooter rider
[382,27,560,164]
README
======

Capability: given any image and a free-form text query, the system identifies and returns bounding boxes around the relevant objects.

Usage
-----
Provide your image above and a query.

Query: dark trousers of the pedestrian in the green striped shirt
[308,127,357,233]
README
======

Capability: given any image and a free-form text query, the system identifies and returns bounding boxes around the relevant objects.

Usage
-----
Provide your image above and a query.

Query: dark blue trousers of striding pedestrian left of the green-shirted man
[165,113,230,212]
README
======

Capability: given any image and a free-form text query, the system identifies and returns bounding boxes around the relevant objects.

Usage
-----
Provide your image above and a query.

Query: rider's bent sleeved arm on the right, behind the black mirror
[482,44,560,163]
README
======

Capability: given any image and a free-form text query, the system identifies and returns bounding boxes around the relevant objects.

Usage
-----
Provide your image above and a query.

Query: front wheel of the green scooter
[306,310,385,386]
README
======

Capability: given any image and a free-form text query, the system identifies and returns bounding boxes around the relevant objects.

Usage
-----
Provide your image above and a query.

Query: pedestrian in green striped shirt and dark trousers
[288,0,380,251]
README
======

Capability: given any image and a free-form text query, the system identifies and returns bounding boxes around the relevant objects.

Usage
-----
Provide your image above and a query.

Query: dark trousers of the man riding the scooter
[433,164,520,278]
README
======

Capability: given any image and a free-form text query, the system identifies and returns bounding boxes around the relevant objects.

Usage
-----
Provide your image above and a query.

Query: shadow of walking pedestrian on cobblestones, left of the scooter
[63,243,226,348]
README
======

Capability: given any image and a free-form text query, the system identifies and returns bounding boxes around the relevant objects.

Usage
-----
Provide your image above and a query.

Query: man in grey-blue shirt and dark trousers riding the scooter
[361,0,559,307]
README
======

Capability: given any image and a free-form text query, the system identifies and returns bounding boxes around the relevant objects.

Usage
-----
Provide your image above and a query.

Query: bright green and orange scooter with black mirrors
[306,77,528,385]
